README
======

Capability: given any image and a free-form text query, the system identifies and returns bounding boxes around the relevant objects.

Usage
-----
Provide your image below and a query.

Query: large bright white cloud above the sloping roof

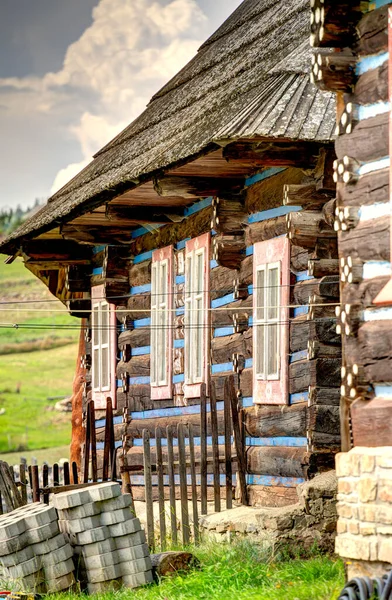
[0,0,207,199]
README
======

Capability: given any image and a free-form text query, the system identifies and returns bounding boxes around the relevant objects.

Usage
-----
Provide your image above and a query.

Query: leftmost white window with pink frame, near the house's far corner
[91,285,116,408]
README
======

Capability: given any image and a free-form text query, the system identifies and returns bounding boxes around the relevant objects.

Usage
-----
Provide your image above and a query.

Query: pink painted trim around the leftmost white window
[91,285,117,410]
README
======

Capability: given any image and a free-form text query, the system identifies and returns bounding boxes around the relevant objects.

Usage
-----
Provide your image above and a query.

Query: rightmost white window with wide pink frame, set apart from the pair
[253,237,290,404]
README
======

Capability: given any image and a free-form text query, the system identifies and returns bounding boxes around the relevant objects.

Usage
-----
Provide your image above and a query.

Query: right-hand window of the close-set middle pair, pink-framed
[184,234,210,398]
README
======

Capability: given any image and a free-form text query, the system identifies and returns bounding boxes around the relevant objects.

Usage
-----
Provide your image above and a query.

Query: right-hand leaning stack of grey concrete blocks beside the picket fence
[52,482,153,593]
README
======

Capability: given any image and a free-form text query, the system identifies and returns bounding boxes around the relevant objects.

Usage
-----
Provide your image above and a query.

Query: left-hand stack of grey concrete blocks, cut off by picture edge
[0,502,75,593]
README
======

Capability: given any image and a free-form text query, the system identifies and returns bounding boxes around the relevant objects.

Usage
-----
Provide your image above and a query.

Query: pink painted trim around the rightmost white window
[253,237,290,404]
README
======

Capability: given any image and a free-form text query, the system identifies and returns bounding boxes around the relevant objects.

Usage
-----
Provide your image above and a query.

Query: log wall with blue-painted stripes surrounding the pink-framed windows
[86,162,341,505]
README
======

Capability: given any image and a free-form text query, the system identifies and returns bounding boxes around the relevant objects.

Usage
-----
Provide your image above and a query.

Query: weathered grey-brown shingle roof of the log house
[3,0,335,253]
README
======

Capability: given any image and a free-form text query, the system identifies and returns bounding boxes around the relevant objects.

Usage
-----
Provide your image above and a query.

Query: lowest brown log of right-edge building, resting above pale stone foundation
[351,398,392,447]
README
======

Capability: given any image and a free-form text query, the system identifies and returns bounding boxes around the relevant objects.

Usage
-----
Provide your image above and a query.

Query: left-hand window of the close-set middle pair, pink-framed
[150,246,173,399]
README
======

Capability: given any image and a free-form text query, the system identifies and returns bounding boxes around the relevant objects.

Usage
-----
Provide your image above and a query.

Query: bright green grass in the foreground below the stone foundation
[57,542,344,600]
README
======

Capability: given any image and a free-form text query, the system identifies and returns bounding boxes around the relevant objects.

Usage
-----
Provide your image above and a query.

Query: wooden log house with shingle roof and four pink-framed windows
[1,0,342,506]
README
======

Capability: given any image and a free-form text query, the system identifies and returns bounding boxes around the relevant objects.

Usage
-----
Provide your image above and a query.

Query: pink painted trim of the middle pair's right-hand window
[184,233,211,398]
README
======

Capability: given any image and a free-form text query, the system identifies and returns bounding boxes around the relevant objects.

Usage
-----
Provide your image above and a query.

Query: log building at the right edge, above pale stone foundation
[311,0,392,451]
